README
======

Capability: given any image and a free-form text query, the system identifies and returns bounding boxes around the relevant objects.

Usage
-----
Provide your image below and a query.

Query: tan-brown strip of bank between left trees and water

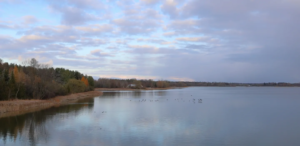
[0,91,102,118]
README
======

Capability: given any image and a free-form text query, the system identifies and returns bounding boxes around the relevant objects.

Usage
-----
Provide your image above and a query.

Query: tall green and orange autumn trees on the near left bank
[0,58,94,100]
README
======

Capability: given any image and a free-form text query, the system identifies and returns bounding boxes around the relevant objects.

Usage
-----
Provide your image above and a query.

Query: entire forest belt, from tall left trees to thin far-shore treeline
[0,58,300,100]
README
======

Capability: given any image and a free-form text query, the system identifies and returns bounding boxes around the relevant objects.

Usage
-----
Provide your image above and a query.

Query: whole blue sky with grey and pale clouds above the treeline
[0,0,300,83]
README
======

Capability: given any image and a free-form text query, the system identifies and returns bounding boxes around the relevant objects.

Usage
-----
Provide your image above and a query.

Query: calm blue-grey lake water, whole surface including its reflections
[0,87,300,146]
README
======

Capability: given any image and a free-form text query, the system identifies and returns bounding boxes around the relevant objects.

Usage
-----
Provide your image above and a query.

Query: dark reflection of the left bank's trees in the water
[0,99,94,145]
